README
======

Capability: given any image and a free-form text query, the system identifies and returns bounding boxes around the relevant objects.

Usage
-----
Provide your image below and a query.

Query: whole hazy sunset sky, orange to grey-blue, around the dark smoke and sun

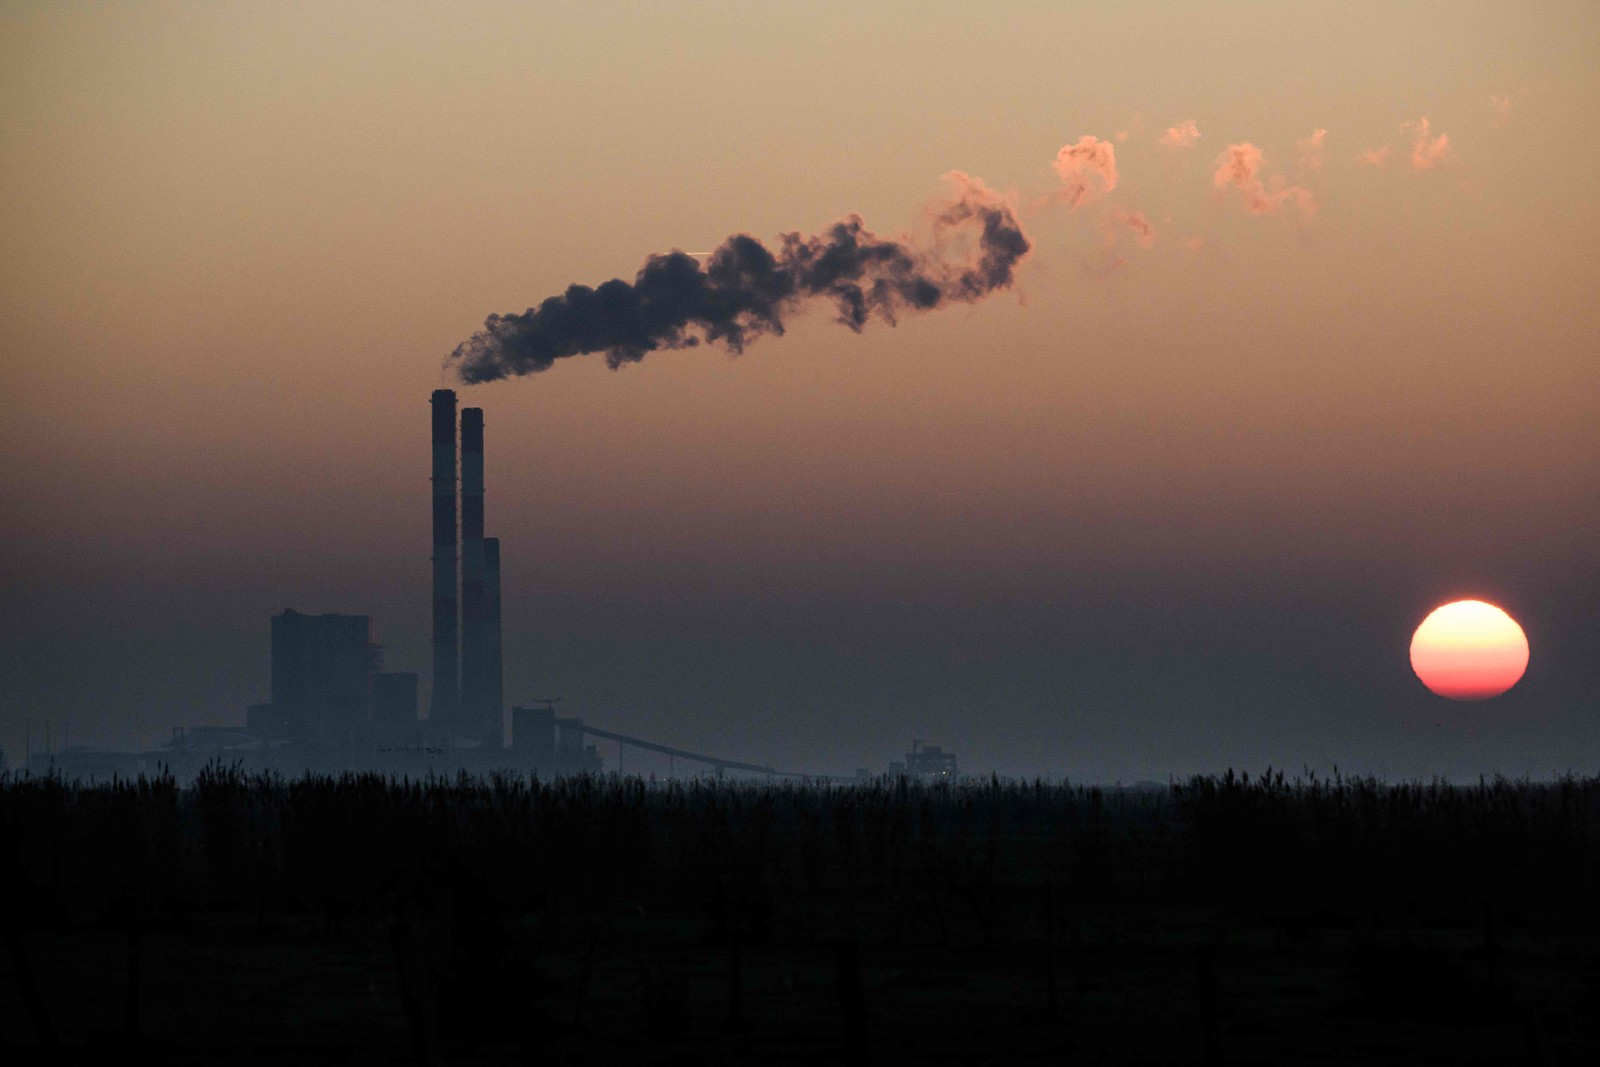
[0,2,1600,782]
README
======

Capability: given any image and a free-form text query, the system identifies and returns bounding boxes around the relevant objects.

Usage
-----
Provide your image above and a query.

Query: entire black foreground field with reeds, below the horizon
[0,771,1600,1064]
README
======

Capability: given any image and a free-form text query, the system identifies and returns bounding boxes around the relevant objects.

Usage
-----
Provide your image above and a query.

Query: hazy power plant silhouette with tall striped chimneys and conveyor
[24,396,958,779]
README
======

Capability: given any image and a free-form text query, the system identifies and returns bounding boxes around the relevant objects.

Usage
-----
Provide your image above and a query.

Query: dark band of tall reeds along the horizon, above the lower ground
[0,765,1600,944]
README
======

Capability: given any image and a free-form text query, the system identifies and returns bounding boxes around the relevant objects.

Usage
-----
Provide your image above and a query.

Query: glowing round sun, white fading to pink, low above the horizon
[1411,600,1528,701]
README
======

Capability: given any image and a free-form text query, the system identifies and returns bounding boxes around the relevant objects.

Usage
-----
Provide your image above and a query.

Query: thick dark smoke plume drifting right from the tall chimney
[450,171,1030,384]
